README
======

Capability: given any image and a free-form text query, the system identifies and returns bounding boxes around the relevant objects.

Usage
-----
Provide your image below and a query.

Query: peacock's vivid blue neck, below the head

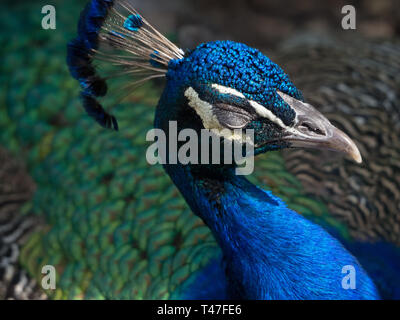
[165,165,379,299]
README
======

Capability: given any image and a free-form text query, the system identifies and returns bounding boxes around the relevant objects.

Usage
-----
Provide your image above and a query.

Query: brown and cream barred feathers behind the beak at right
[280,41,400,246]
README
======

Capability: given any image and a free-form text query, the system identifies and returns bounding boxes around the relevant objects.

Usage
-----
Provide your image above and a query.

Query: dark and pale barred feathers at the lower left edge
[0,149,45,299]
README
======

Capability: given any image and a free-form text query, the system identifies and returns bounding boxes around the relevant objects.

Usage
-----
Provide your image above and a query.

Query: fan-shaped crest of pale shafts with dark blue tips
[67,0,184,130]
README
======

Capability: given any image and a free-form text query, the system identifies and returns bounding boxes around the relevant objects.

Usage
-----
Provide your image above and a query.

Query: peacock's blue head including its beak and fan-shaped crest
[67,0,361,166]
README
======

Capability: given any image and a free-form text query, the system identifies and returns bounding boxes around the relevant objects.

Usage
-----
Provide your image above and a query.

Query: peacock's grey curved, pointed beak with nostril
[278,91,362,163]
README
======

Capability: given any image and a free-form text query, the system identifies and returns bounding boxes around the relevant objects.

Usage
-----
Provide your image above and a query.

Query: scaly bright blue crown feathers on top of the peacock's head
[167,41,303,125]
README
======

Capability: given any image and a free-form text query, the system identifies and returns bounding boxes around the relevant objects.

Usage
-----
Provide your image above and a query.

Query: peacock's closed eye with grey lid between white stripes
[213,103,253,129]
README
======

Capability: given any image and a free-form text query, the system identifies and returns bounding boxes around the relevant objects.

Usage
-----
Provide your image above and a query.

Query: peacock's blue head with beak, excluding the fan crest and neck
[156,41,362,163]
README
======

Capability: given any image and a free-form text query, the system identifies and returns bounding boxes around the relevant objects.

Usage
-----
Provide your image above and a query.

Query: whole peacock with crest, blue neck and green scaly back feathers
[0,0,400,299]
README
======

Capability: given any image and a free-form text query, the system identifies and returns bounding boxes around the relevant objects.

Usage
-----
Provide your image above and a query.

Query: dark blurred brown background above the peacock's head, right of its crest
[135,0,400,48]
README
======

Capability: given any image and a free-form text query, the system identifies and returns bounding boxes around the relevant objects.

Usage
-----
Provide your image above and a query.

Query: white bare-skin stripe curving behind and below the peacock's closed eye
[185,87,251,143]
